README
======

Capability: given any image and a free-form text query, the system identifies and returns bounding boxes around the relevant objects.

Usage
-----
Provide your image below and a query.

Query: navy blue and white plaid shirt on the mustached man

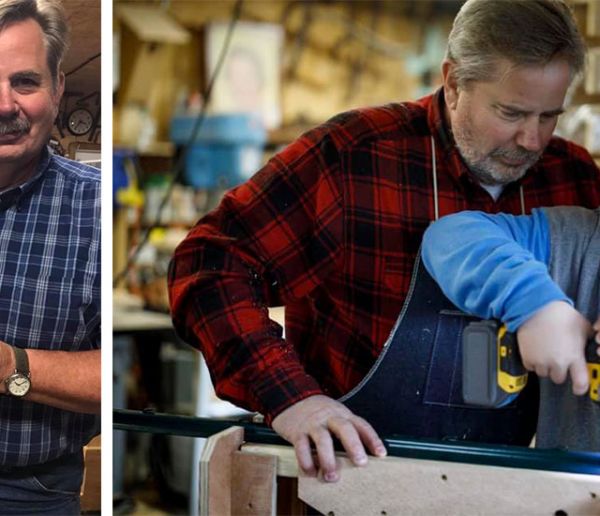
[0,150,100,467]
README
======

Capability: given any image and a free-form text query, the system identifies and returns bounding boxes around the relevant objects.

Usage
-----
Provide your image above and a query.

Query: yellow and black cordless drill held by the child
[462,320,600,407]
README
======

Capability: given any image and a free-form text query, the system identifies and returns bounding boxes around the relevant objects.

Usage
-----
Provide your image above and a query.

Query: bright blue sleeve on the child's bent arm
[422,209,572,331]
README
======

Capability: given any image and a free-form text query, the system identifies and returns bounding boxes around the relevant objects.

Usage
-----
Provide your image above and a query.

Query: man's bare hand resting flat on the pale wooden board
[272,395,387,482]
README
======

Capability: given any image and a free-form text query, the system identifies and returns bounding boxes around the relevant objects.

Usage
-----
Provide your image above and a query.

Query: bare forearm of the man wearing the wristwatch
[0,343,101,414]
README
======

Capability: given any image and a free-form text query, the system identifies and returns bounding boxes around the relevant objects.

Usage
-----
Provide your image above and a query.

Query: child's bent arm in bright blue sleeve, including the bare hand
[422,210,591,394]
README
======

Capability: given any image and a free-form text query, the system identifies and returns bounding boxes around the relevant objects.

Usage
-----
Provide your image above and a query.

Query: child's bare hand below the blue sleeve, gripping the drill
[517,301,600,395]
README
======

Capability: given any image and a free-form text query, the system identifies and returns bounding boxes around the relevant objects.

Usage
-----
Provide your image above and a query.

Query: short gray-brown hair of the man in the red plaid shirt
[446,0,586,87]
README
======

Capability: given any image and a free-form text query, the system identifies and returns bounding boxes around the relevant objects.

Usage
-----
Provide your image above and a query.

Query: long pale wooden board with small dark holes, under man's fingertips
[298,457,600,516]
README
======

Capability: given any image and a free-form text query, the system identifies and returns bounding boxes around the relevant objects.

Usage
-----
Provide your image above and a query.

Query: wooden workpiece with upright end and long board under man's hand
[200,427,600,516]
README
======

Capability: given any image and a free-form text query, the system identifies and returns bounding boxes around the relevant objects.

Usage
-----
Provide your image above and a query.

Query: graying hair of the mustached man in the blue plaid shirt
[0,0,69,87]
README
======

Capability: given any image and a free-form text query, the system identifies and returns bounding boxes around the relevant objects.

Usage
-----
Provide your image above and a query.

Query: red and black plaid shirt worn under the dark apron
[169,91,600,420]
